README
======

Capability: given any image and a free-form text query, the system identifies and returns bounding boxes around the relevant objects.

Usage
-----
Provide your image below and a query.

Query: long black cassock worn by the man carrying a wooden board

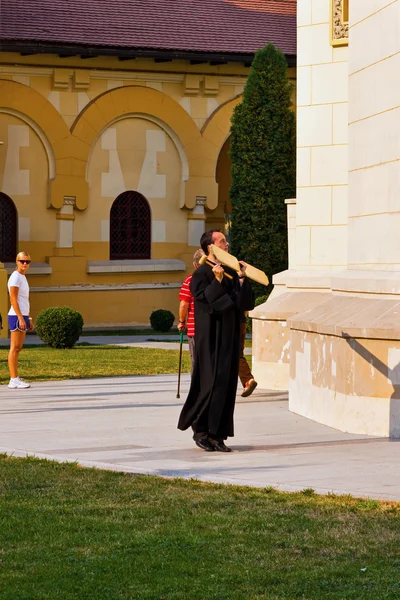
[178,264,254,439]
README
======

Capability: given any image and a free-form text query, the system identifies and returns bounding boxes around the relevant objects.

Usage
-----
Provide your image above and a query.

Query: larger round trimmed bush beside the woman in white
[36,306,83,348]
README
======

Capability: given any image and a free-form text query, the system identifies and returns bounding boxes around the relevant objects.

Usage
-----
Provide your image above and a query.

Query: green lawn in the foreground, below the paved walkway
[0,456,400,600]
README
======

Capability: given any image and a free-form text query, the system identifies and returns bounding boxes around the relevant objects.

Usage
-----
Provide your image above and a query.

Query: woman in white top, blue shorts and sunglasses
[8,252,33,389]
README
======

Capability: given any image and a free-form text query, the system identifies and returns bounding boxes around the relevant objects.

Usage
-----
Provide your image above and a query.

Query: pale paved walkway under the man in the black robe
[0,375,400,501]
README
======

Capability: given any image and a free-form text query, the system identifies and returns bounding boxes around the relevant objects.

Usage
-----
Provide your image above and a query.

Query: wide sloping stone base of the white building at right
[251,271,400,438]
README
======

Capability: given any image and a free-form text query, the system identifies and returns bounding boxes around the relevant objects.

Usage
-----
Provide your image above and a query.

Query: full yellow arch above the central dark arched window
[71,86,217,208]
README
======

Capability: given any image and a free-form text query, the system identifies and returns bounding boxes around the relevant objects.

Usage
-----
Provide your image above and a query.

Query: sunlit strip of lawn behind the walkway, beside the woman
[0,344,190,384]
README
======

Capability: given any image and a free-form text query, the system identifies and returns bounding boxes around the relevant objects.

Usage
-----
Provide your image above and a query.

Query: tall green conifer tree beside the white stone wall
[229,44,296,295]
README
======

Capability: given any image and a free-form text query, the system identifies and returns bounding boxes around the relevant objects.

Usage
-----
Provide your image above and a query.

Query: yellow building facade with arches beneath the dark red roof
[0,47,295,333]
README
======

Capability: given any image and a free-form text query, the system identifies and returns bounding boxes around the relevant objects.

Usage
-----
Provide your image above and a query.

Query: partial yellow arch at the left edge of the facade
[0,79,88,209]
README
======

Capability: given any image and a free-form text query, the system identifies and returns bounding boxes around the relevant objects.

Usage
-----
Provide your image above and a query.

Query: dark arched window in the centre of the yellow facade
[110,191,151,260]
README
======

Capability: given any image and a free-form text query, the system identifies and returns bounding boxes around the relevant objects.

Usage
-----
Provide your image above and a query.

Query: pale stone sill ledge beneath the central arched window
[86,259,186,275]
